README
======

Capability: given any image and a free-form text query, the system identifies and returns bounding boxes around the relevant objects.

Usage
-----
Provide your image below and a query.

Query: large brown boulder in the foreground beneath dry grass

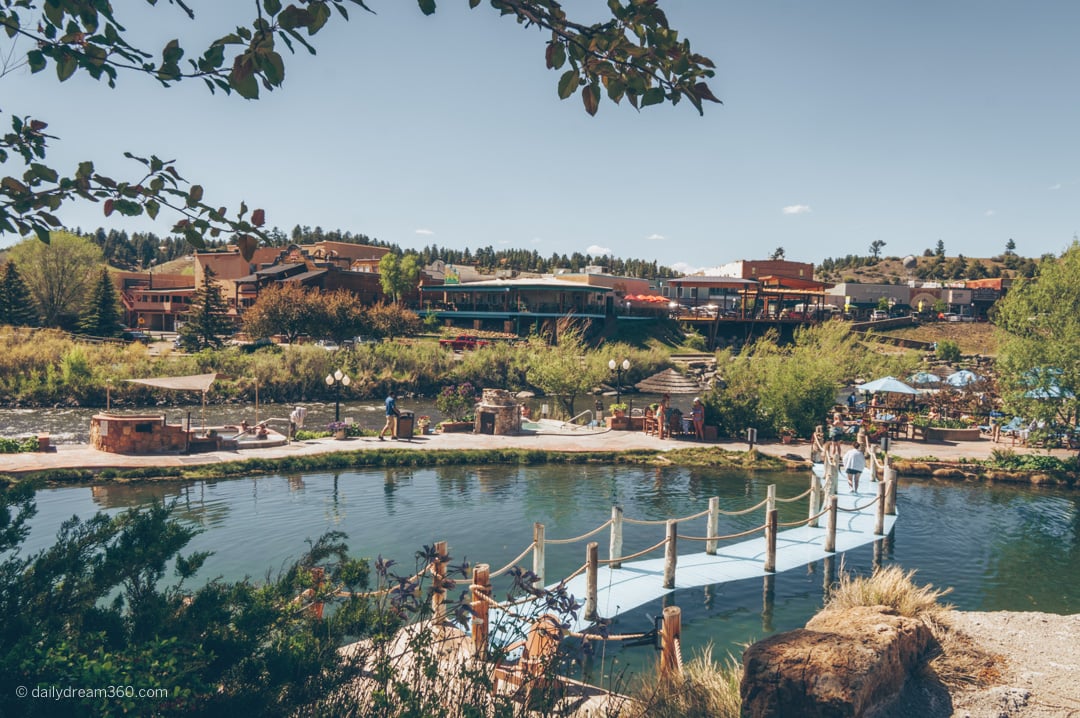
[740,606,932,718]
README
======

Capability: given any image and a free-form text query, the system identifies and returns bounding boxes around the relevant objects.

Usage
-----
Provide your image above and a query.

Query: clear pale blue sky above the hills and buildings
[6,0,1080,270]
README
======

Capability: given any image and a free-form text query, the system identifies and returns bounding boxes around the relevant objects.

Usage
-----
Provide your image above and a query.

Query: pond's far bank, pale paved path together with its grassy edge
[0,431,1074,483]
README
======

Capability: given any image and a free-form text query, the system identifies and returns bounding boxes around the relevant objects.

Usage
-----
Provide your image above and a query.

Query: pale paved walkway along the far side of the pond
[0,431,1075,474]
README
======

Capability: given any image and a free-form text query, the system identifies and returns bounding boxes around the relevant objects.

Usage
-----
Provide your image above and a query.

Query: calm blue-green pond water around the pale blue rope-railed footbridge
[19,465,1080,682]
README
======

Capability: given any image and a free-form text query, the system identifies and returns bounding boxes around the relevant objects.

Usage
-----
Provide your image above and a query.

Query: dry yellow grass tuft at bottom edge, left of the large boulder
[627,644,742,718]
